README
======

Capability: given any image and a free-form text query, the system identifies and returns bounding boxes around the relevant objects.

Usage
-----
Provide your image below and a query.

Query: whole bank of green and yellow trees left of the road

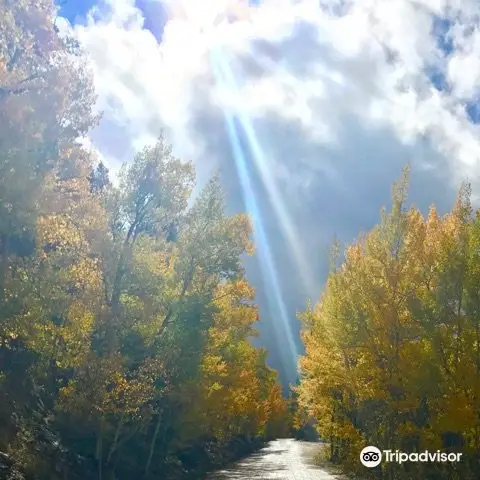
[0,0,285,479]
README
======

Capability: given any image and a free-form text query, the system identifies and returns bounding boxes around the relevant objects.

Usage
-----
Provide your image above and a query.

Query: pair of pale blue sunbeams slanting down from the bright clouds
[159,0,314,376]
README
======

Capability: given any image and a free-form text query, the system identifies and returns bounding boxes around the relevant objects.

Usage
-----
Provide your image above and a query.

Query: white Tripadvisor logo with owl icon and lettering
[360,446,462,468]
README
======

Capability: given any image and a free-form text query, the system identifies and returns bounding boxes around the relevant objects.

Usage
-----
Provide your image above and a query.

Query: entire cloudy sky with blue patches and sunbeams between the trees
[57,0,480,382]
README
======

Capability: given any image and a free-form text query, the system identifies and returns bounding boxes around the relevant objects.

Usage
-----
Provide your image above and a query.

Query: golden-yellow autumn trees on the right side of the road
[299,169,480,478]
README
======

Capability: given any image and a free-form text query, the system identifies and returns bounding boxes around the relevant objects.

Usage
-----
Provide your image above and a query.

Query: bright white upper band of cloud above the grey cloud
[62,0,480,184]
